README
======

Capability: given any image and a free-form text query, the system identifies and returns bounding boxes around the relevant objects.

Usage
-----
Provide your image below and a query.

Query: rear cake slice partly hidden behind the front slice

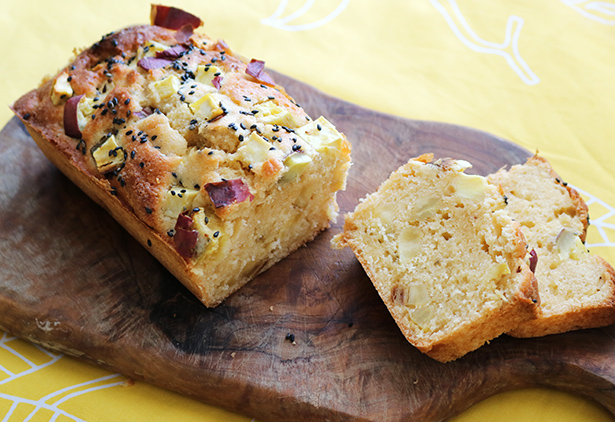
[488,156,615,337]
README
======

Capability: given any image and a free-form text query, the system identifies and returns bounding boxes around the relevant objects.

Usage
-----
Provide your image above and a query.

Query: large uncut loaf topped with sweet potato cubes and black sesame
[12,6,350,306]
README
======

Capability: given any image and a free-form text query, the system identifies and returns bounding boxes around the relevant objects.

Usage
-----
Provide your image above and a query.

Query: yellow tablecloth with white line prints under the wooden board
[0,0,615,422]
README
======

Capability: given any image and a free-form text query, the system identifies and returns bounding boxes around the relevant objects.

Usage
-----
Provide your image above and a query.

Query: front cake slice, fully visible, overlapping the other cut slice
[332,154,539,362]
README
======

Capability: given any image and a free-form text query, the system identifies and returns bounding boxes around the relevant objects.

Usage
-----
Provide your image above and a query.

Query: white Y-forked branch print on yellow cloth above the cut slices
[429,0,540,85]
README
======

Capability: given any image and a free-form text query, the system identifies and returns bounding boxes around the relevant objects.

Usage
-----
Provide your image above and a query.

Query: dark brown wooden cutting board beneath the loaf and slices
[0,73,615,421]
